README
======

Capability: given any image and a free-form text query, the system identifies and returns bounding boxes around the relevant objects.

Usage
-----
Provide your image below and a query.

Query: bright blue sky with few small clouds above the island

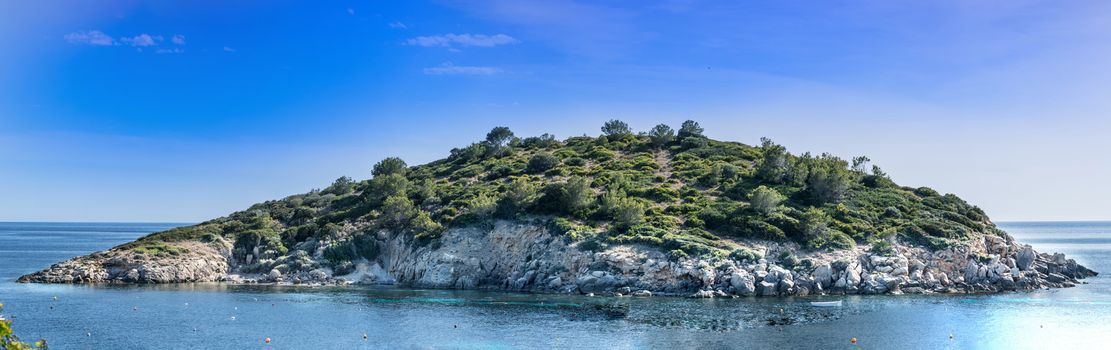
[0,0,1111,221]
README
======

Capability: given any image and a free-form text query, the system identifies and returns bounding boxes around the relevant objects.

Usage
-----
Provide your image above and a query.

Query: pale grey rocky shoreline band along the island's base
[19,221,1097,298]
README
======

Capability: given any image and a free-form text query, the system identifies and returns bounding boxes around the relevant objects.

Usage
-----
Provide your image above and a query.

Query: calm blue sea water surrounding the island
[0,222,1111,349]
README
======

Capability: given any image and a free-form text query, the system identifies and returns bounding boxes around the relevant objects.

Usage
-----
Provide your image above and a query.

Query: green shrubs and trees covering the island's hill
[126,120,999,270]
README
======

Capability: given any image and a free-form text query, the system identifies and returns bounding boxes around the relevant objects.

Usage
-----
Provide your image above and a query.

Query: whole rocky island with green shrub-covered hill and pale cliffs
[19,120,1095,298]
